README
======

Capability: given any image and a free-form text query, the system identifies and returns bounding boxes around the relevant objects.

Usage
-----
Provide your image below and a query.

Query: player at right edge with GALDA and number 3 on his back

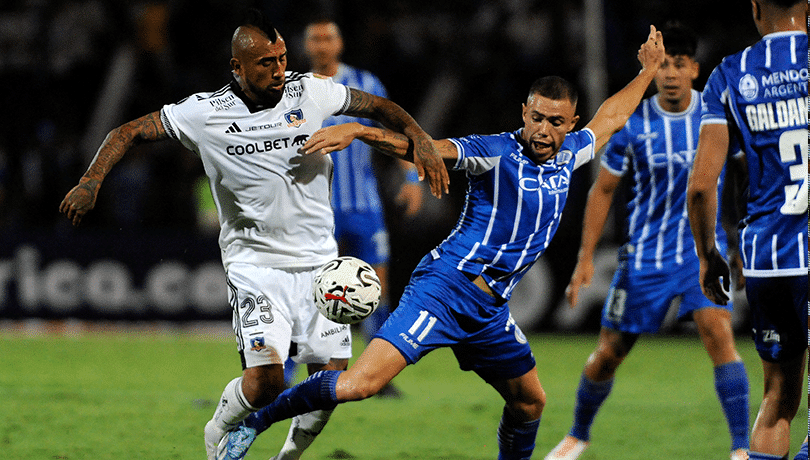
[687,0,808,460]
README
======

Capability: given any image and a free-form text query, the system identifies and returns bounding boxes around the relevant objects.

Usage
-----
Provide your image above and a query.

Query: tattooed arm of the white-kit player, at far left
[59,112,169,225]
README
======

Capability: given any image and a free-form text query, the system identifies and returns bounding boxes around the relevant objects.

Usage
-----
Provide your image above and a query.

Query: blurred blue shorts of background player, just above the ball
[335,210,389,265]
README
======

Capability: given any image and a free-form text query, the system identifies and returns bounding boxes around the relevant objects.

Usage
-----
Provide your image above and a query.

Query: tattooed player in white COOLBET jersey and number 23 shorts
[60,10,449,460]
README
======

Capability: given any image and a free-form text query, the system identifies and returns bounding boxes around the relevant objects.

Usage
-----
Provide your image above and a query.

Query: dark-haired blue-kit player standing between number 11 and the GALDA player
[546,23,748,460]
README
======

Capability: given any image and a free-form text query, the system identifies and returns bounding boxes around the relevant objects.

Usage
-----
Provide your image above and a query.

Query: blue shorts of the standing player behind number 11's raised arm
[602,252,733,334]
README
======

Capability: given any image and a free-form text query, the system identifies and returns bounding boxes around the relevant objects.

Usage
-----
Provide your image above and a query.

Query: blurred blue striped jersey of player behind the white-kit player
[323,64,388,213]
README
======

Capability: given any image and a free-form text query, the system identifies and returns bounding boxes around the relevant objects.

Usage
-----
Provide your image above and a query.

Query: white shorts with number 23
[227,264,352,368]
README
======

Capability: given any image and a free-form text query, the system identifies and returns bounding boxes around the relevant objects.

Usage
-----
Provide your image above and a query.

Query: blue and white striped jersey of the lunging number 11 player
[433,129,595,299]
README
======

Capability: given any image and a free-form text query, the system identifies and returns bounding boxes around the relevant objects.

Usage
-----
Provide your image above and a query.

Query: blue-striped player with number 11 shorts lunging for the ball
[215,27,664,460]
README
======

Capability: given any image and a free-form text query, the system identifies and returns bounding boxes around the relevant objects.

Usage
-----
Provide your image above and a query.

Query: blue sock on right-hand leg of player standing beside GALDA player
[714,361,748,451]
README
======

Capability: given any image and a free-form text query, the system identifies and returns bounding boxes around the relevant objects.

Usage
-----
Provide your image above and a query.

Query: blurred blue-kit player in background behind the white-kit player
[274,17,422,460]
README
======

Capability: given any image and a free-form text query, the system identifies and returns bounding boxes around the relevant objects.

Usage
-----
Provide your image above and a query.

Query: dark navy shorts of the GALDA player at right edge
[745,276,808,362]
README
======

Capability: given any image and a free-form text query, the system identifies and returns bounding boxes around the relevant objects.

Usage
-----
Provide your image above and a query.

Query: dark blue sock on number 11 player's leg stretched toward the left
[244,371,343,433]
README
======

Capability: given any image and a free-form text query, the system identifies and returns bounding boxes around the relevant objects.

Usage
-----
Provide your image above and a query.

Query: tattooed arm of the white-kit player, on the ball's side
[344,88,450,198]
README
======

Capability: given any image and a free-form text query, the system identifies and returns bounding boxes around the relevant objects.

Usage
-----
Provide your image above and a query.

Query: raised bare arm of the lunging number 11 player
[586,25,665,150]
